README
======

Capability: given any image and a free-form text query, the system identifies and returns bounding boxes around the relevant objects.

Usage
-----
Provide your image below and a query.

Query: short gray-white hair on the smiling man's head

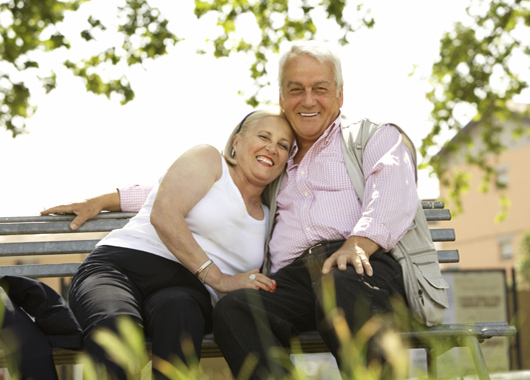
[278,41,344,96]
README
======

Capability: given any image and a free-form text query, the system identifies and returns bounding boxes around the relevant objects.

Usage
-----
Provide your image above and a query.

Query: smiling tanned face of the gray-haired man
[280,55,342,147]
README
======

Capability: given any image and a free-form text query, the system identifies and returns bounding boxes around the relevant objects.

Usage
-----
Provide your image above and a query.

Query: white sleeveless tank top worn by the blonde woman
[97,157,269,305]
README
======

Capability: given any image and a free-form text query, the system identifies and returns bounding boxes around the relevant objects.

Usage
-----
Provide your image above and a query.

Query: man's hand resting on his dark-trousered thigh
[322,236,379,276]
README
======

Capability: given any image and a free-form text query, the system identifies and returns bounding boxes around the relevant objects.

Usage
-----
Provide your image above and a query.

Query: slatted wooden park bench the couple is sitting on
[0,205,516,379]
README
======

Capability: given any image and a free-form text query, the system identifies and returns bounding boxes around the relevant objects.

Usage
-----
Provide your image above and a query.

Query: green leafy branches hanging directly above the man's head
[195,0,374,107]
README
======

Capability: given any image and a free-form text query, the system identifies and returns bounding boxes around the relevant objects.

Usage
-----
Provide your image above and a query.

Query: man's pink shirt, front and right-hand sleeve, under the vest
[269,116,418,273]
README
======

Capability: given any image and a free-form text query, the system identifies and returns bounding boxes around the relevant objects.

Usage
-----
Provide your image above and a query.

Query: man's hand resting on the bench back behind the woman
[40,191,120,230]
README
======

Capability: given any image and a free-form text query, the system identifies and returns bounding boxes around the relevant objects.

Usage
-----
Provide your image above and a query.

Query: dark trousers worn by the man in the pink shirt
[213,248,405,379]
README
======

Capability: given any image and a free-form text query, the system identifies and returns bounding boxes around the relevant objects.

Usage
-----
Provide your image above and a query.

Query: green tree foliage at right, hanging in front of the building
[420,0,530,211]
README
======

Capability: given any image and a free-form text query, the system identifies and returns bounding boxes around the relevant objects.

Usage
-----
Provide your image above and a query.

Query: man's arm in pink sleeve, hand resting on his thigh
[322,126,418,276]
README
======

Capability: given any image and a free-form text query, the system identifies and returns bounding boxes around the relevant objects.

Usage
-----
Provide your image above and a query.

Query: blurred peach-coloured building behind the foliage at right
[440,104,530,278]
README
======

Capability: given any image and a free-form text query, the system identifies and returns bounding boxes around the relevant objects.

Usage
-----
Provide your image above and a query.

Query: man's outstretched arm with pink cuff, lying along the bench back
[41,185,152,230]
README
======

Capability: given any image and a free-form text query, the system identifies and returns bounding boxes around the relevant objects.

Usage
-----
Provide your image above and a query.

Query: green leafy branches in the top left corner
[0,0,178,136]
